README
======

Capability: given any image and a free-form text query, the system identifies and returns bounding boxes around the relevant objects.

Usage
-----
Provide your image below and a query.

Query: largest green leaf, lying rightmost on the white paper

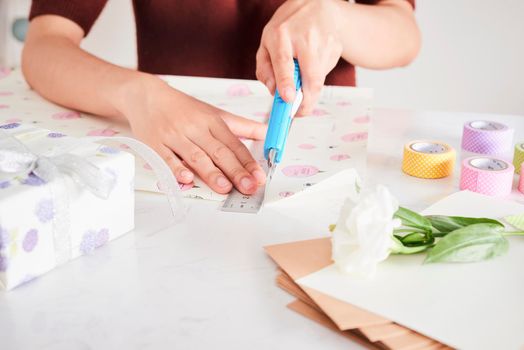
[424,223,509,263]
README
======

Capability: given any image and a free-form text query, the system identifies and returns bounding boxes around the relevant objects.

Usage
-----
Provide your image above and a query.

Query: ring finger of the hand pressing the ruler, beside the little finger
[167,137,233,194]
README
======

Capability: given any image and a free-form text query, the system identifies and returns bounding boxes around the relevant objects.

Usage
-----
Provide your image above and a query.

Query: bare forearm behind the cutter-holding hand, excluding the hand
[338,0,420,69]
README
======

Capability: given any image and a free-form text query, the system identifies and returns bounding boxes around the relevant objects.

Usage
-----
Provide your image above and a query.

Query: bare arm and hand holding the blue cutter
[257,0,420,114]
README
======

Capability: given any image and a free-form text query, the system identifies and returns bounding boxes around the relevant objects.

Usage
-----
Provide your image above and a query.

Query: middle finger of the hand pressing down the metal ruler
[197,134,258,194]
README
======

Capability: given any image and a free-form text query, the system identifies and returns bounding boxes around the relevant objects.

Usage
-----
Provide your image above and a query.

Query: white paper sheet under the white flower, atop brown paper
[298,192,524,350]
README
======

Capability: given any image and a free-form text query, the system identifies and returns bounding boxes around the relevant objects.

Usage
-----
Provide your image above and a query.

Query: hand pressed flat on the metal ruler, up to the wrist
[123,77,266,194]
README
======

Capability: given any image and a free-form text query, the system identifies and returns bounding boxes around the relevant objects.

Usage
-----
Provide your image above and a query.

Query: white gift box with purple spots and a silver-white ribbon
[0,123,135,290]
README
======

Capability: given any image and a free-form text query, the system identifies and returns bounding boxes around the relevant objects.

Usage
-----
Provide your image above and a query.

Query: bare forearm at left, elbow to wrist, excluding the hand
[22,16,156,118]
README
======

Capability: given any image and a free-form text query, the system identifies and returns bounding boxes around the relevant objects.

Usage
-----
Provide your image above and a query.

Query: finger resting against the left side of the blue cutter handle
[267,29,296,102]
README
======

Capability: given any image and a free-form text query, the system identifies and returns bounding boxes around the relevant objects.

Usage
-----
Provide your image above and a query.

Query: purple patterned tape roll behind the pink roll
[462,120,514,156]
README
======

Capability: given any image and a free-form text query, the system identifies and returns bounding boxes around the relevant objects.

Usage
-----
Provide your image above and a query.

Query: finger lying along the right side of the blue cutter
[297,48,326,115]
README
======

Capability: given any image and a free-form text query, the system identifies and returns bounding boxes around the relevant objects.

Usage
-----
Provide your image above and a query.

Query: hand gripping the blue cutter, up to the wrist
[256,0,343,115]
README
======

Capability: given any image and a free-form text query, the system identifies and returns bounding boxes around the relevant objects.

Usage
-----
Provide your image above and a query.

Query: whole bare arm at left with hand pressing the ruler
[22,15,265,193]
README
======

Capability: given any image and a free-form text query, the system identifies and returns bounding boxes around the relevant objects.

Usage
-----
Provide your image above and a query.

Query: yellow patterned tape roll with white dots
[402,141,456,179]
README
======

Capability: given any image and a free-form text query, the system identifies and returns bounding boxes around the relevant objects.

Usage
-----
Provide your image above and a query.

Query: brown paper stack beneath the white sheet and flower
[265,238,450,350]
